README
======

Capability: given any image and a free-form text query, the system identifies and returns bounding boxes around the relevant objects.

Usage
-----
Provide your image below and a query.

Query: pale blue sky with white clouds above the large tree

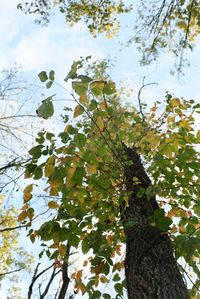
[0,0,200,295]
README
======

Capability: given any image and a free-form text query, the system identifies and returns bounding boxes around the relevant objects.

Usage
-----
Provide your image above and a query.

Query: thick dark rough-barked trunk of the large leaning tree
[121,147,189,299]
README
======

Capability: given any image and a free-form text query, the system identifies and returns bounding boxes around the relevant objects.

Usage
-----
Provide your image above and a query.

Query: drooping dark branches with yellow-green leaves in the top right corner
[133,0,200,72]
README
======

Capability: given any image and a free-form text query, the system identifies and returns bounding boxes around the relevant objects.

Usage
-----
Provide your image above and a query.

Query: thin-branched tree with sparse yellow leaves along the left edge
[0,66,41,299]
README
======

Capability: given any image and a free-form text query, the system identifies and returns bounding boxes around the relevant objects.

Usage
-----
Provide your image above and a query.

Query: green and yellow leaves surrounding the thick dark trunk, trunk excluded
[19,61,200,298]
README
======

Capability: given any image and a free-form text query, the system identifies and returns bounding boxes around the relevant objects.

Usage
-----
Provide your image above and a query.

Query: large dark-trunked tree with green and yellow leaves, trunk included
[19,60,200,299]
